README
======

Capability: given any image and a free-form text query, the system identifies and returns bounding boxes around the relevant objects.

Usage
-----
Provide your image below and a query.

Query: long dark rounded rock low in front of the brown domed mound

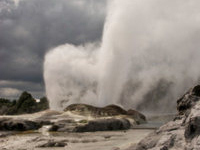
[74,119,131,132]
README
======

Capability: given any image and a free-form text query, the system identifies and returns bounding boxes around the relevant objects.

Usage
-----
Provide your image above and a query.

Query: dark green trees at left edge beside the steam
[0,91,49,115]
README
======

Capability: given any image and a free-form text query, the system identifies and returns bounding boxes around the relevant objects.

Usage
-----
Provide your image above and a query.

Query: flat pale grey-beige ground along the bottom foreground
[0,129,153,150]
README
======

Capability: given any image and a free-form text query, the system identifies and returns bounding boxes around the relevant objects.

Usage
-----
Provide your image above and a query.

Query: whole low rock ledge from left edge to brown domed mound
[0,104,146,132]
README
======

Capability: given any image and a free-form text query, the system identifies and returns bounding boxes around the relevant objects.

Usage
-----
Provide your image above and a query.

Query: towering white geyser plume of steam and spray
[44,0,200,112]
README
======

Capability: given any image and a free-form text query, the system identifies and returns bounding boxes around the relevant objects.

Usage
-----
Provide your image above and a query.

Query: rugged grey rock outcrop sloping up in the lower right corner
[127,85,200,150]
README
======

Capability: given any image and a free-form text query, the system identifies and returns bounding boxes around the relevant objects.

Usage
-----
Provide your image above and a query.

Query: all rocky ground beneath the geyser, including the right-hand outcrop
[0,85,200,150]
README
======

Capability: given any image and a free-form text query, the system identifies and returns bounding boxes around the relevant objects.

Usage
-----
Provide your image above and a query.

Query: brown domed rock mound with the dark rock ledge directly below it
[56,104,146,132]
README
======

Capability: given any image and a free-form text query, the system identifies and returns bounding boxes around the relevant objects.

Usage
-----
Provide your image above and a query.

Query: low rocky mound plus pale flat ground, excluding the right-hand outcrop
[0,104,152,150]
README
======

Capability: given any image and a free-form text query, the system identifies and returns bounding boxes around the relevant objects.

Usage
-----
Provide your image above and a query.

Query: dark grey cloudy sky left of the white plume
[0,0,106,98]
